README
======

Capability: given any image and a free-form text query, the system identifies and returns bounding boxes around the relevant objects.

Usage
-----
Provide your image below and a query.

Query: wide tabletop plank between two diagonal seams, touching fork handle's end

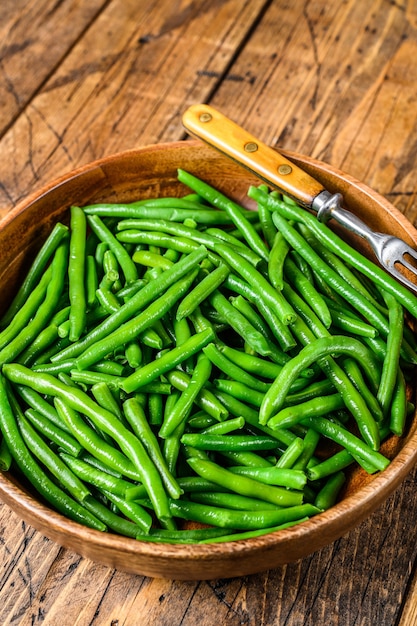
[0,0,265,215]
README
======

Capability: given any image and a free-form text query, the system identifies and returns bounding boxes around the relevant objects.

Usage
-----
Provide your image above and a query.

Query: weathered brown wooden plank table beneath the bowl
[0,0,417,626]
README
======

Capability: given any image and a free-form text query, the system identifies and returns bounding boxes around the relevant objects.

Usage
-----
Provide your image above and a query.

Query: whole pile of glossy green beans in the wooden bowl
[0,170,417,543]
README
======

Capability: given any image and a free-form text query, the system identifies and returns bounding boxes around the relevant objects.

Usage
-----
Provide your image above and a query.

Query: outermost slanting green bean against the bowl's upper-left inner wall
[0,222,68,328]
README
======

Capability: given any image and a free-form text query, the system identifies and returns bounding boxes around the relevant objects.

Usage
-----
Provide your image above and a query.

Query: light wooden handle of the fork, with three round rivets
[182,104,325,208]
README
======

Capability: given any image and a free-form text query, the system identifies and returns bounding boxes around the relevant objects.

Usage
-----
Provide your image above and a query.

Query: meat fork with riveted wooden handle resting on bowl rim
[182,104,417,292]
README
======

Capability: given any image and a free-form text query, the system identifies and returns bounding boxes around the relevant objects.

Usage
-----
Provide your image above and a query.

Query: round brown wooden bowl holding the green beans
[0,141,417,580]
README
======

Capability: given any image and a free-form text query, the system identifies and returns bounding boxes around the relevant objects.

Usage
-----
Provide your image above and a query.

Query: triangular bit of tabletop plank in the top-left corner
[0,0,108,136]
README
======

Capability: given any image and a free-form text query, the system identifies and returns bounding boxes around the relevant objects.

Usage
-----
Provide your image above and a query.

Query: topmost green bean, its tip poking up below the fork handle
[178,169,269,261]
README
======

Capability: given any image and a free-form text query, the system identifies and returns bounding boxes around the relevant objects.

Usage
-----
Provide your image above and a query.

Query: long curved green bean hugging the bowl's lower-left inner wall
[0,366,106,531]
